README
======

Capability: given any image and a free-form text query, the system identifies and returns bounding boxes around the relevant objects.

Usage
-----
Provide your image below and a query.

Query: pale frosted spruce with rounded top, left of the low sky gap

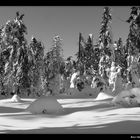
[45,35,65,95]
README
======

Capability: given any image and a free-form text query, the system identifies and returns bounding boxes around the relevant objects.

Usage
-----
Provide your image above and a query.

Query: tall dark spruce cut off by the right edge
[126,7,140,87]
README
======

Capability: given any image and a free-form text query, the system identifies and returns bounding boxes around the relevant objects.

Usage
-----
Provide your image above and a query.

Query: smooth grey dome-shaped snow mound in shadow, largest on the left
[25,97,64,114]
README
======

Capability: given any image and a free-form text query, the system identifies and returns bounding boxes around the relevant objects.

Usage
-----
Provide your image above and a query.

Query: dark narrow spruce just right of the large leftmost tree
[29,37,44,95]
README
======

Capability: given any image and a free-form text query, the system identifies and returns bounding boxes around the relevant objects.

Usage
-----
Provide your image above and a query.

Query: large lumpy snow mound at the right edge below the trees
[112,88,140,107]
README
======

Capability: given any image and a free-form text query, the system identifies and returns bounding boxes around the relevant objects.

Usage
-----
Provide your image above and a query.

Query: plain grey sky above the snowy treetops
[0,6,131,57]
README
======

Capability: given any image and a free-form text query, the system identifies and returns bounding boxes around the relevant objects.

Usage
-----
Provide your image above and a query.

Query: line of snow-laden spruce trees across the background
[0,7,140,96]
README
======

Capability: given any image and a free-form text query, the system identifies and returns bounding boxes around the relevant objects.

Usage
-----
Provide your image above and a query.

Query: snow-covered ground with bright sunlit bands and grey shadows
[0,97,140,134]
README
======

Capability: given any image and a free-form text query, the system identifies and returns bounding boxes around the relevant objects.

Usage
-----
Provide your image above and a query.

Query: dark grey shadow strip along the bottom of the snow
[0,121,140,134]
